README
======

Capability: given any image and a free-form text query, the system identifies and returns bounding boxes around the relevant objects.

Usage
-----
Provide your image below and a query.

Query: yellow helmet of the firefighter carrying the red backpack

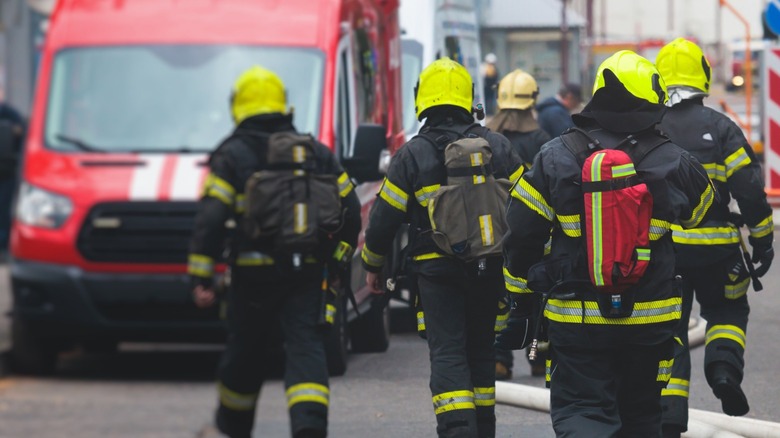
[593,50,666,104]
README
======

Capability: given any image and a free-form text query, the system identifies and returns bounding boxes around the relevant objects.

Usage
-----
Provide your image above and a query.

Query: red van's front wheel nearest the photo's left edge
[11,319,58,375]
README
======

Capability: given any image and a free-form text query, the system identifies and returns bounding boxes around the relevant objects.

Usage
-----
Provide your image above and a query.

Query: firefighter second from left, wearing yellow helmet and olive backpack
[362,58,522,437]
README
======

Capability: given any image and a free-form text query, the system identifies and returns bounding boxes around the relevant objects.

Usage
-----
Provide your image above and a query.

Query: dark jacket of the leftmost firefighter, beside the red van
[188,114,361,285]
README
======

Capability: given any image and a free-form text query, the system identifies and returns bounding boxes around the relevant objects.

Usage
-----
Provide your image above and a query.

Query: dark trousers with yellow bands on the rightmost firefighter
[662,253,750,431]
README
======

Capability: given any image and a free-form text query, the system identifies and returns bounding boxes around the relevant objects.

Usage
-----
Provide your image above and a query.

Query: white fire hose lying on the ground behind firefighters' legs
[496,318,780,438]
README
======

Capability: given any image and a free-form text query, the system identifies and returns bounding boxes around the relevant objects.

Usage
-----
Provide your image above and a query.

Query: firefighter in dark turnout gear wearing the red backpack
[504,50,715,437]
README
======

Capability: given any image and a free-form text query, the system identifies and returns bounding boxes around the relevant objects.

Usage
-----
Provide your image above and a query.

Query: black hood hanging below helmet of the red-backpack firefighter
[572,69,666,134]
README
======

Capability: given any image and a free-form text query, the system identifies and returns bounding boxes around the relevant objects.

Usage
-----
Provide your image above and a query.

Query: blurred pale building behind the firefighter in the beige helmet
[478,0,586,101]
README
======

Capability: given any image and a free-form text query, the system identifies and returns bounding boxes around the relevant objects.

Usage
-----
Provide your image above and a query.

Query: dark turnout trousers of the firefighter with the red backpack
[550,338,673,438]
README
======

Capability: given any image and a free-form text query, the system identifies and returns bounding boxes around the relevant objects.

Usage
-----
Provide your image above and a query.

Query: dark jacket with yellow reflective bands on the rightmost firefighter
[661,98,774,267]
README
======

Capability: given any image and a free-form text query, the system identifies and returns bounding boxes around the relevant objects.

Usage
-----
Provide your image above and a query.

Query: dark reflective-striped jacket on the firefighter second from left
[362,112,523,272]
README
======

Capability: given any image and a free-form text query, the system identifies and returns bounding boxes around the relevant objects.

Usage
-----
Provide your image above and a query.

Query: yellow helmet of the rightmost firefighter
[655,38,712,93]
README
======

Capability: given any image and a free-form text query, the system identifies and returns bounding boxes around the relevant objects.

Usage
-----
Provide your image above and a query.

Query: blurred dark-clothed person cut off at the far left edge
[0,88,24,252]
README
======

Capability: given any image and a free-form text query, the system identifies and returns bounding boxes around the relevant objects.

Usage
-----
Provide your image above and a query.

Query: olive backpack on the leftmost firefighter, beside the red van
[243,132,342,264]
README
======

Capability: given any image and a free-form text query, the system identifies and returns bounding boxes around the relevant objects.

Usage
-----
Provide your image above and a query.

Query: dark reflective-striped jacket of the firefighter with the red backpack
[504,122,715,346]
